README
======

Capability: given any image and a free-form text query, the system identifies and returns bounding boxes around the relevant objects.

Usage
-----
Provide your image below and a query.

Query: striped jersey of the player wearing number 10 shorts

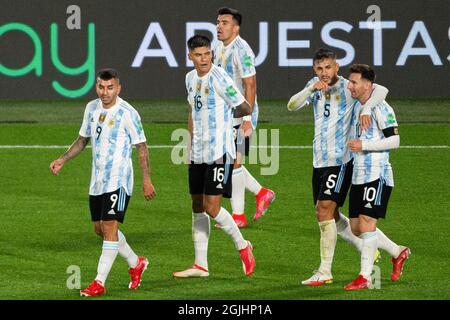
[350,101,398,187]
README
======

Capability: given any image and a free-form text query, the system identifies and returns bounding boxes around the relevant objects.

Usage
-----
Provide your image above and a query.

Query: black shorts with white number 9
[89,188,131,223]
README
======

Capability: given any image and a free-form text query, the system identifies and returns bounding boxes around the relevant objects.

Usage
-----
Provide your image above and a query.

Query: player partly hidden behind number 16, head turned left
[214,7,275,228]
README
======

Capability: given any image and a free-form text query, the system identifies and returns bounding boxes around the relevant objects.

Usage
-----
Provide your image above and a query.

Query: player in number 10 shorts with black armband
[345,64,410,290]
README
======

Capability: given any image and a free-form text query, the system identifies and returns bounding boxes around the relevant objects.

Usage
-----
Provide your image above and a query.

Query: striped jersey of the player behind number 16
[214,36,259,129]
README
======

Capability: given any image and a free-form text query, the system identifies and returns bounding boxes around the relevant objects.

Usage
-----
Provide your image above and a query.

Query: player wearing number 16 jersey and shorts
[173,35,256,278]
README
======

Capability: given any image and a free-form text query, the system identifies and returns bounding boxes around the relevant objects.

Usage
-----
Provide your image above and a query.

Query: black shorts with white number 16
[189,155,233,198]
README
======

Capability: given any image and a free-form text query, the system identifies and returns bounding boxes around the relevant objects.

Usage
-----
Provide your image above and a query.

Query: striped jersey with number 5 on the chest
[306,76,354,168]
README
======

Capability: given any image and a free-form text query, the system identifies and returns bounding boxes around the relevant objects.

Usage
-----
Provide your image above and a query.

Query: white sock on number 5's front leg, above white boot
[319,219,337,275]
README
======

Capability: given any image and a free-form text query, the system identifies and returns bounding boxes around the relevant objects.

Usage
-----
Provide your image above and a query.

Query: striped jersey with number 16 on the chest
[186,65,245,163]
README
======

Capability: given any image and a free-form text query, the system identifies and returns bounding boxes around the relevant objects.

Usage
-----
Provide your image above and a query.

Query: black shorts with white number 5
[312,159,353,207]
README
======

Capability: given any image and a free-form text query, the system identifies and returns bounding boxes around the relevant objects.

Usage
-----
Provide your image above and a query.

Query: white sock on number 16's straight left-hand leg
[192,212,211,270]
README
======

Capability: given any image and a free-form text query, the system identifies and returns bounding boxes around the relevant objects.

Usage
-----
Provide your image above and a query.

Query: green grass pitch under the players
[0,99,450,300]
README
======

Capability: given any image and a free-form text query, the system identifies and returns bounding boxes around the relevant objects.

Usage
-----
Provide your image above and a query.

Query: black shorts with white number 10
[349,179,393,219]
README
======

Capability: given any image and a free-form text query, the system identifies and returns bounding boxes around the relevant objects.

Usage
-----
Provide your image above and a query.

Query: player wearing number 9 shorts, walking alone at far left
[50,69,156,296]
